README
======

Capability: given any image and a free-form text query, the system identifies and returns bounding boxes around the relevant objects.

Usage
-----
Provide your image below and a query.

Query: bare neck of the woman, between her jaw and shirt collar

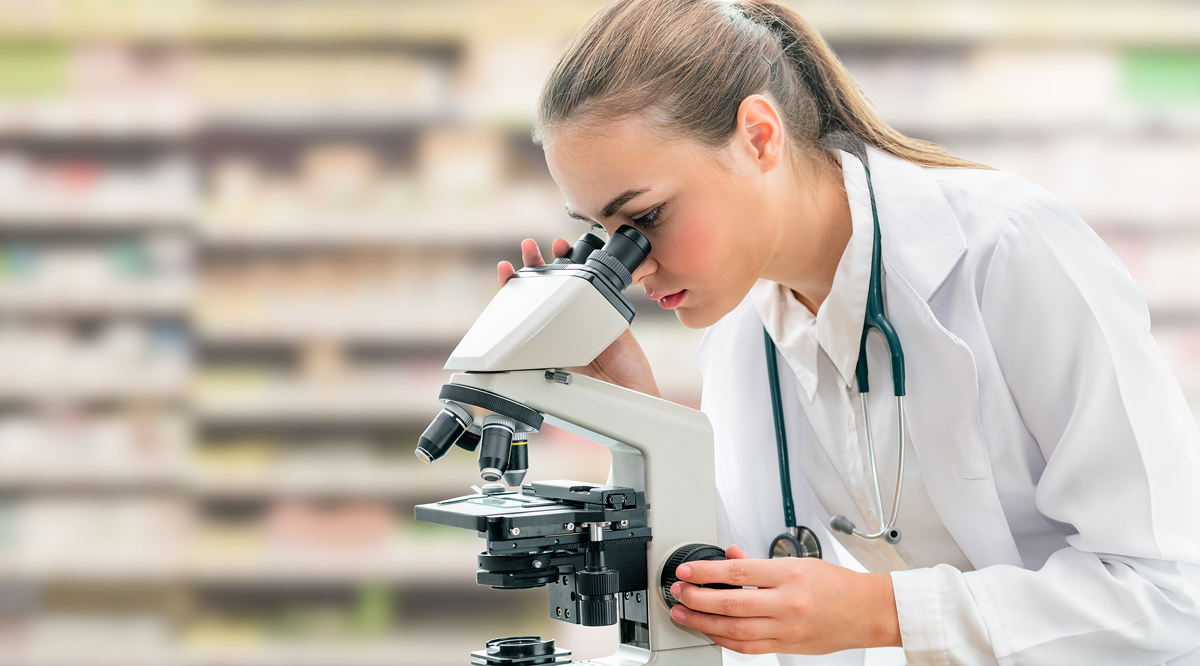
[762,156,853,314]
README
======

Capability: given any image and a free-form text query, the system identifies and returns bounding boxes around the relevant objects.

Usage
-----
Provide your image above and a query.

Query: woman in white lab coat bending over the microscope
[499,0,1200,665]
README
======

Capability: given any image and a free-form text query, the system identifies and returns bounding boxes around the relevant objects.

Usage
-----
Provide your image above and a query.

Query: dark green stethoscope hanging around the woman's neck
[762,132,905,558]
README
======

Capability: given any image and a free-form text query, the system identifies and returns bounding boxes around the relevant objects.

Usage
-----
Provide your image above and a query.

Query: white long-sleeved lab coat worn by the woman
[696,148,1200,666]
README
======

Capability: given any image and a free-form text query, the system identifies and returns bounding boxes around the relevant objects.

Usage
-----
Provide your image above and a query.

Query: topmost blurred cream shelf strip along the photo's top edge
[0,0,1200,46]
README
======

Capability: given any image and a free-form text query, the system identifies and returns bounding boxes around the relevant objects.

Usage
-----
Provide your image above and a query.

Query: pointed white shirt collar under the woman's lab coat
[750,151,874,402]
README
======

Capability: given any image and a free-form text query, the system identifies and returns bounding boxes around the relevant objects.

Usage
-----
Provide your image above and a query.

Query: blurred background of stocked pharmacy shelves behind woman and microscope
[0,0,1200,666]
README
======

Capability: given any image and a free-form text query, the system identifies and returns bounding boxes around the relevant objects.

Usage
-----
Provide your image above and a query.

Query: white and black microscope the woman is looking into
[415,226,727,666]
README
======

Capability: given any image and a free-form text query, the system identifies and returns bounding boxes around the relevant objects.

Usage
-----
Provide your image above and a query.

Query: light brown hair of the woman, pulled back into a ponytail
[533,0,991,169]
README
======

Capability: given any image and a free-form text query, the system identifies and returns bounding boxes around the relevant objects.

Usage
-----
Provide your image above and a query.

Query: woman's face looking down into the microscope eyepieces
[544,116,778,329]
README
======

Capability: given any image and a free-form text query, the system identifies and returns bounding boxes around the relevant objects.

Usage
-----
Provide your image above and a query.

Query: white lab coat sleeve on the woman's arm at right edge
[893,197,1200,666]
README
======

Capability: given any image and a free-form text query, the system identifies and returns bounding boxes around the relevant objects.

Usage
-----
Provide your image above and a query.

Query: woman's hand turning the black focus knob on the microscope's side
[671,546,900,654]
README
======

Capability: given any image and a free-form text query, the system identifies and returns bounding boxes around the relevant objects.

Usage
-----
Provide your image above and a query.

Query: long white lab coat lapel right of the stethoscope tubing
[868,148,1021,569]
